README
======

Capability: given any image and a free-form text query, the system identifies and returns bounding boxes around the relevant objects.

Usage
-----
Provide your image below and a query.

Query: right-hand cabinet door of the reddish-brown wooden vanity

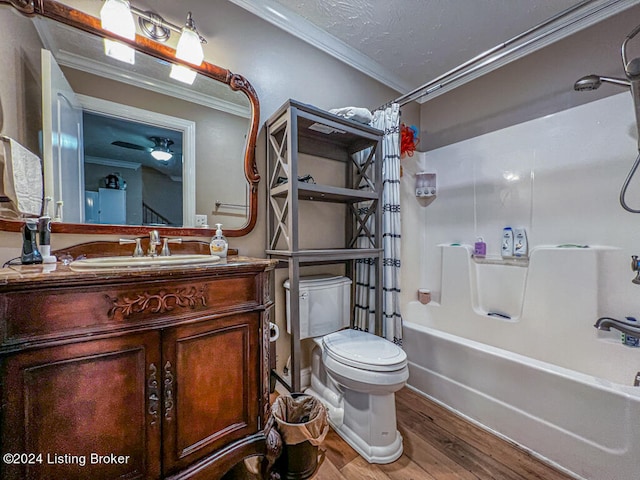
[162,312,260,475]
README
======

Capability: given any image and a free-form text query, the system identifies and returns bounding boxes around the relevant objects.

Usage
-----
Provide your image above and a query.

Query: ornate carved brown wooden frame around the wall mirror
[0,0,260,237]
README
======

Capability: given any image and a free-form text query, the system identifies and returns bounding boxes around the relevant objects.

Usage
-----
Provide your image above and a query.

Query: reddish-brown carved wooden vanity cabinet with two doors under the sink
[0,261,273,480]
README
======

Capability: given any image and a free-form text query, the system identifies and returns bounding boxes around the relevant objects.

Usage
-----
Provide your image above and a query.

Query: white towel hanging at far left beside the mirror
[1,138,43,216]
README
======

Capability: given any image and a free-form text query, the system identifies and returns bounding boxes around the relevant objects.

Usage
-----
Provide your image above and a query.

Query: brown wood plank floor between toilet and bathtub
[314,388,571,480]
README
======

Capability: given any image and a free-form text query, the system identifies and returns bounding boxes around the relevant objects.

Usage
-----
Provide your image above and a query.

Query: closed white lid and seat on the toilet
[322,329,407,372]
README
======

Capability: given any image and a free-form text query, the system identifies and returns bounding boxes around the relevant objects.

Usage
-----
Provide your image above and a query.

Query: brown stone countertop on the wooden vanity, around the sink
[0,255,277,288]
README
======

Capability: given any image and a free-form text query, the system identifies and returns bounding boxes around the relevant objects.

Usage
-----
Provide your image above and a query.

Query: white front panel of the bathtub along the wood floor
[403,321,640,480]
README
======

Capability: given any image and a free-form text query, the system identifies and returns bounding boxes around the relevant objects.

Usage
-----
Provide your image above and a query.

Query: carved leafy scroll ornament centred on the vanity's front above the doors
[107,286,207,318]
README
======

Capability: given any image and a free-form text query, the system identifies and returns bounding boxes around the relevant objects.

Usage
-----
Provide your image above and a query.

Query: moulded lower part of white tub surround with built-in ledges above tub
[404,245,640,385]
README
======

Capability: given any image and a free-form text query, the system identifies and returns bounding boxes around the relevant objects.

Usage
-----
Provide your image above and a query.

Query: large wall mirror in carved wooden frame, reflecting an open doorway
[0,0,260,237]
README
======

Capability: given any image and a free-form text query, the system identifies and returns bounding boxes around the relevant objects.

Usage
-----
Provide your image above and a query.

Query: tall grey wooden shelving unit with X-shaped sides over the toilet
[266,100,383,391]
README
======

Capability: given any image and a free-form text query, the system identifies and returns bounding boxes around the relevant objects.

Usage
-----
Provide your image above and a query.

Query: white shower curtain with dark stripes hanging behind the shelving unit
[354,103,402,346]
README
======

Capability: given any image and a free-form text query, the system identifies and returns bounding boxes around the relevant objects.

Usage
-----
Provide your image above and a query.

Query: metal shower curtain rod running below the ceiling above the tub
[378,0,626,109]
